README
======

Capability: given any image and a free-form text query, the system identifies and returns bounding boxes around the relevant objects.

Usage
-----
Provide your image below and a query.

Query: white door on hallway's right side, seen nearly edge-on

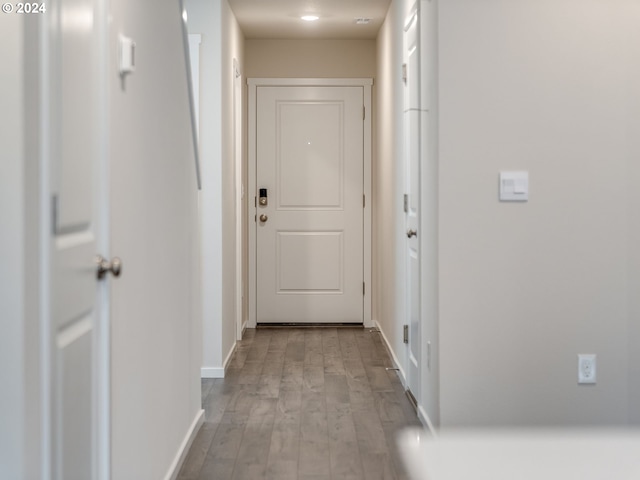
[404,10,422,400]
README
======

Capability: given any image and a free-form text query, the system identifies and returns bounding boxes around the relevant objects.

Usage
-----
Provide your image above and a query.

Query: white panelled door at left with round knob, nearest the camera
[45,0,104,480]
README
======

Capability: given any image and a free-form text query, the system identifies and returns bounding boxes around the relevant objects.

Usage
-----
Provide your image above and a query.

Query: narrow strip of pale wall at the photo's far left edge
[0,15,26,478]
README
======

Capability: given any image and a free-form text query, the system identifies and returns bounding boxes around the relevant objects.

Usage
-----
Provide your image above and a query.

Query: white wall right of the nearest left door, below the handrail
[107,0,201,474]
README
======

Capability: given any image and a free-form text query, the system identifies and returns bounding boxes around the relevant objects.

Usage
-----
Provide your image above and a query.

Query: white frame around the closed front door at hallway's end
[247,78,373,328]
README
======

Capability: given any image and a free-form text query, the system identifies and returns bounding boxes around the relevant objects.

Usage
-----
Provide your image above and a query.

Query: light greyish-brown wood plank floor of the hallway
[178,328,420,480]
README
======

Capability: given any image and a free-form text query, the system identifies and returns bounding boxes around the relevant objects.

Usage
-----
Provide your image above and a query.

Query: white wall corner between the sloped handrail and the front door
[186,0,244,377]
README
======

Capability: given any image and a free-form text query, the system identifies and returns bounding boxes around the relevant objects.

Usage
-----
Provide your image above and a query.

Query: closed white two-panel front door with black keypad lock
[255,86,364,323]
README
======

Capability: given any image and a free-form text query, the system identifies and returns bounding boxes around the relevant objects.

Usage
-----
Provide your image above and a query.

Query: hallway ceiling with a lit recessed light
[228,0,391,39]
